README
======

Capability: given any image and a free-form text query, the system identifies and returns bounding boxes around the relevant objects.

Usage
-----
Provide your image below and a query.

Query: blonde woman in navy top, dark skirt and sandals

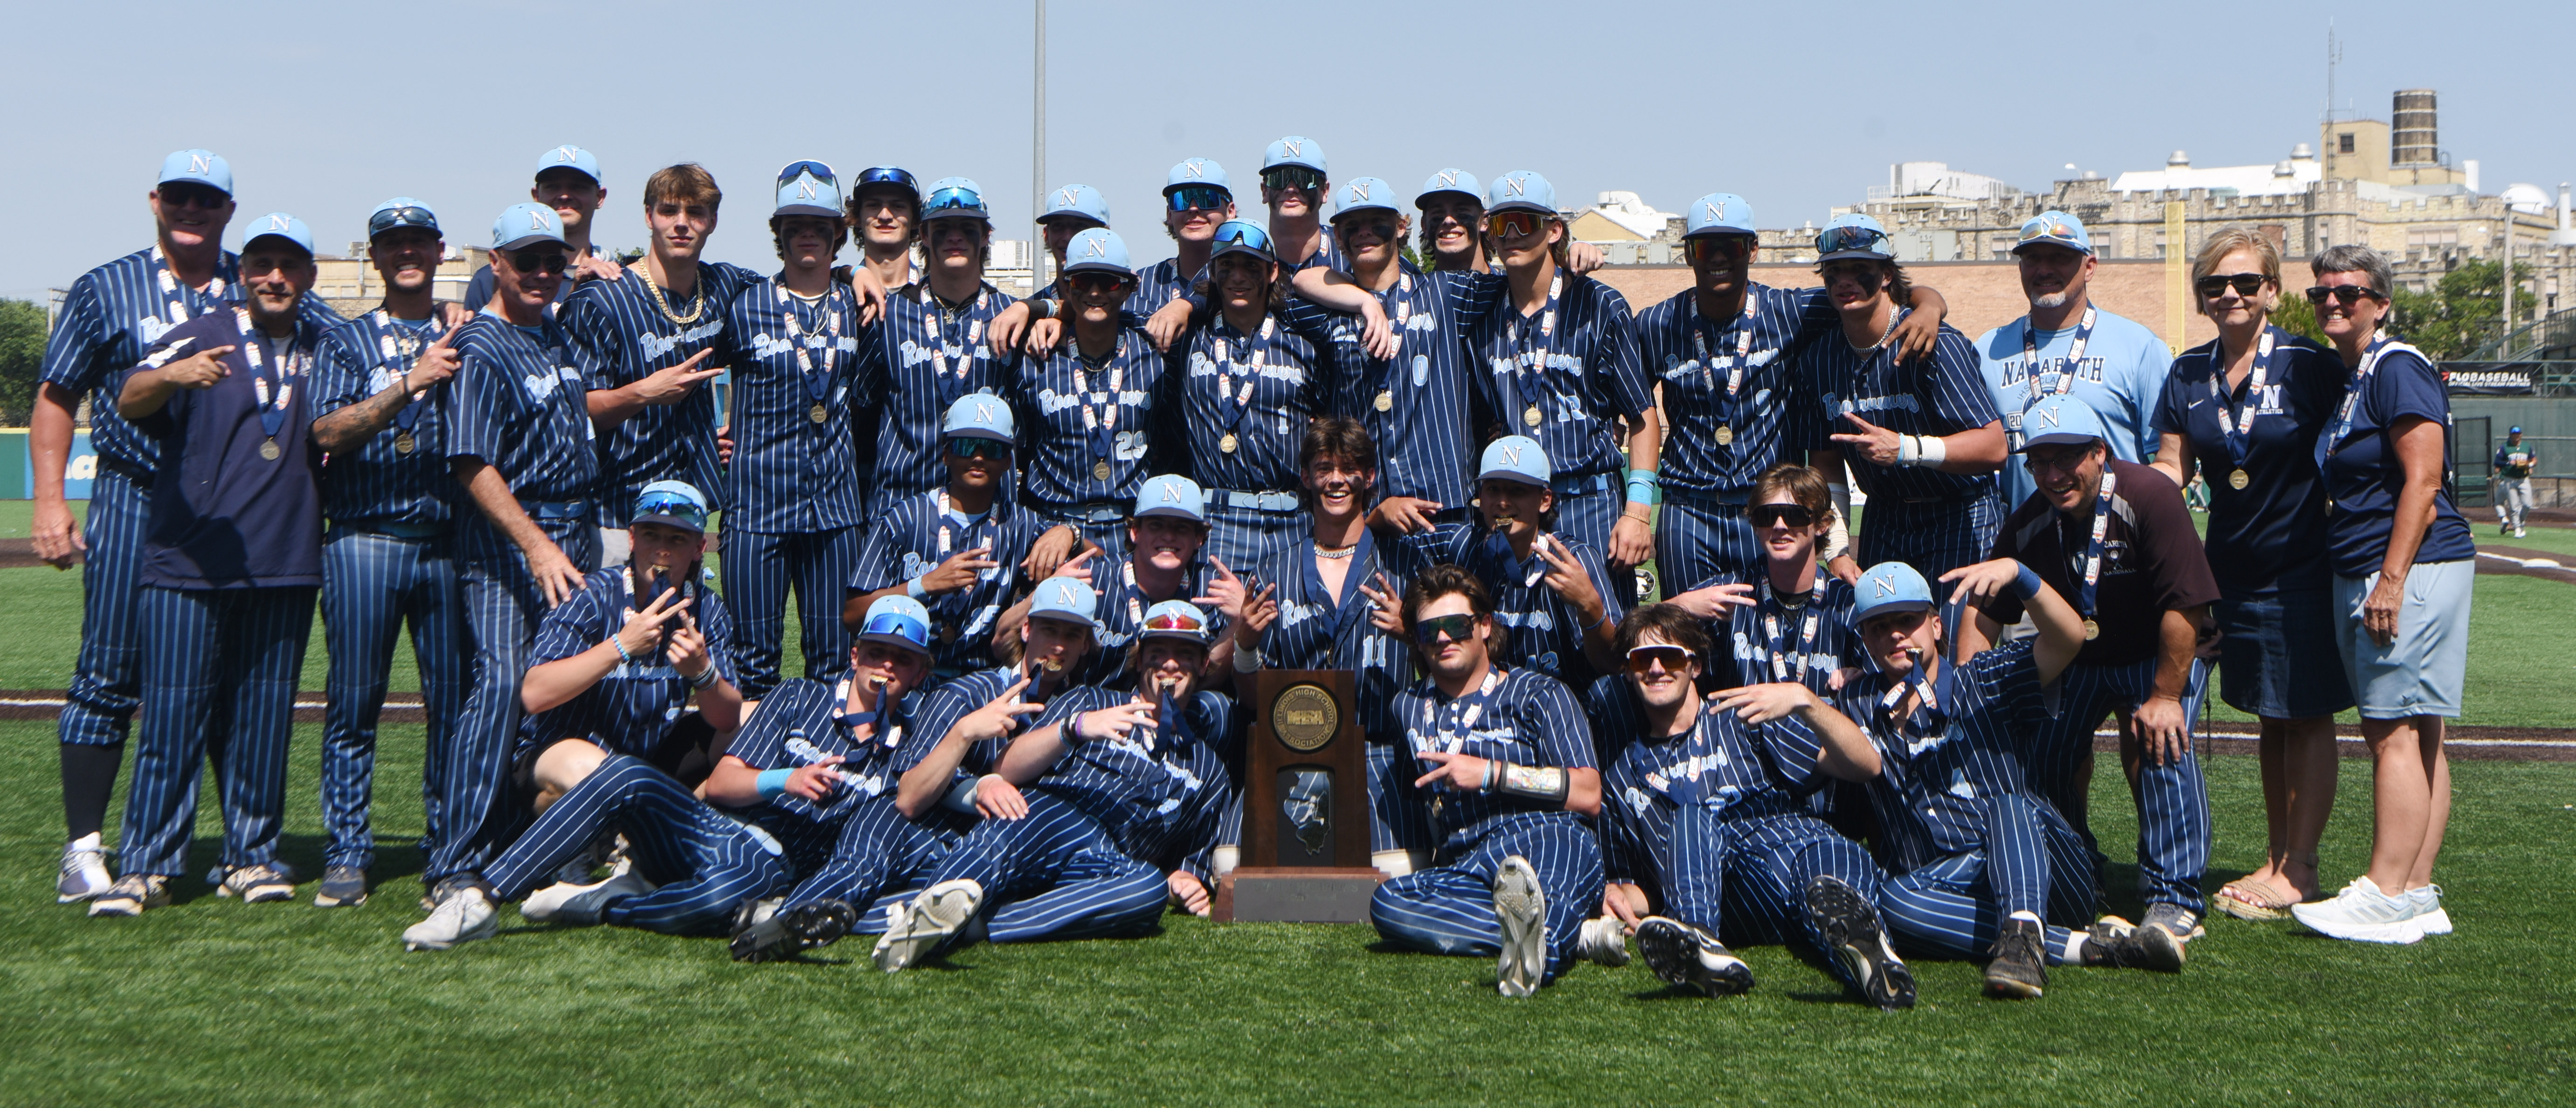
[2154,227,2352,920]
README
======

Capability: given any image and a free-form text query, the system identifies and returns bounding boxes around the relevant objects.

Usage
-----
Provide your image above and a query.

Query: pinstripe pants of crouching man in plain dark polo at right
[2025,657,2210,912]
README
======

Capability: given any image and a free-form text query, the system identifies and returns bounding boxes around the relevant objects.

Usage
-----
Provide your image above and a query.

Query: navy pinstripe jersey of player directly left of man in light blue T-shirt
[1798,309,2001,500]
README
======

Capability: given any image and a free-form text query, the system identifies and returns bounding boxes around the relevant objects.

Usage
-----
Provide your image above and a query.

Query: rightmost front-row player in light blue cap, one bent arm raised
[1808,559,2182,1000]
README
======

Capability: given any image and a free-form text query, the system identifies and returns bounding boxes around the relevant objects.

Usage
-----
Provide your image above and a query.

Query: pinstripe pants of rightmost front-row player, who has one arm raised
[1878,794,2097,963]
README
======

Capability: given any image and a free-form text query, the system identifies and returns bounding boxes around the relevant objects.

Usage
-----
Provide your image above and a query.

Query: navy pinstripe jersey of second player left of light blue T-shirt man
[1636,283,1842,500]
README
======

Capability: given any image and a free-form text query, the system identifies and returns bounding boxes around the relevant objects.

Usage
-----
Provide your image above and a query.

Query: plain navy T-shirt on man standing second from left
[116,312,322,590]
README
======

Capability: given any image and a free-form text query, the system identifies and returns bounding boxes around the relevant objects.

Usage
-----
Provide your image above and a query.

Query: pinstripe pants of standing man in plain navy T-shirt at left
[118,585,314,876]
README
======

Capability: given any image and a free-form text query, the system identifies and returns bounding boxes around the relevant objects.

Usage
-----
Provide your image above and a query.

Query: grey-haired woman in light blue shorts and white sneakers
[2290,245,2478,943]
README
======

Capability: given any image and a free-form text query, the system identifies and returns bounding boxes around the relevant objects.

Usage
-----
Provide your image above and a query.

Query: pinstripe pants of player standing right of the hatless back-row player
[719,526,866,701]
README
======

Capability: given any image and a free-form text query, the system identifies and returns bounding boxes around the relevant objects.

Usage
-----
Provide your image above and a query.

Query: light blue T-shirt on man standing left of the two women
[1976,307,2174,510]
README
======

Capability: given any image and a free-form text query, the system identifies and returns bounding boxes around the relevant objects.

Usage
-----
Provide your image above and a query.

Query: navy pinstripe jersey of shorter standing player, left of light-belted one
[1010,327,1164,510]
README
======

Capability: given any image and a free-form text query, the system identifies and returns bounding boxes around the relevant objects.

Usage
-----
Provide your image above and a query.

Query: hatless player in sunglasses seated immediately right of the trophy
[1368,567,1628,997]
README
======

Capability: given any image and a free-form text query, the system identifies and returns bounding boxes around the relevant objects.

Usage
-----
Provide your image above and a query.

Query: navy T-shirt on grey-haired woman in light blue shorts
[2319,340,2478,577]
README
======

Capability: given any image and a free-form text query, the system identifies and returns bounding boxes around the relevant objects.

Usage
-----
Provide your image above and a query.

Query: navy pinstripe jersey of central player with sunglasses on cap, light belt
[1154,312,1334,492]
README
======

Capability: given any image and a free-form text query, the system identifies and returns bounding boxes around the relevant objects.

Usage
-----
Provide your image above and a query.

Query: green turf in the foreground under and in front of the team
[0,722,2576,1105]
